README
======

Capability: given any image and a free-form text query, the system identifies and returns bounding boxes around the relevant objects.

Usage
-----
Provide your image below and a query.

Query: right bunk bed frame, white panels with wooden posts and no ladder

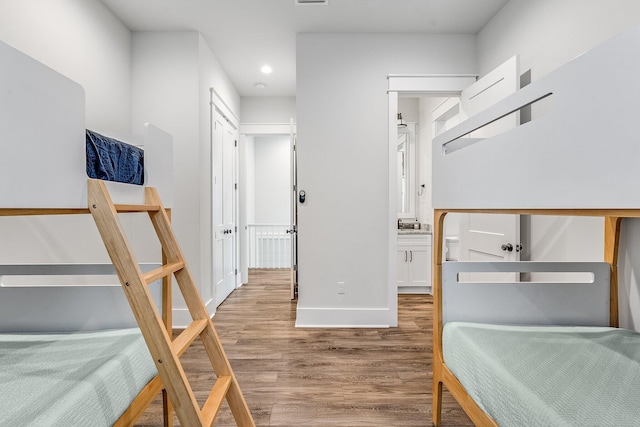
[432,26,640,426]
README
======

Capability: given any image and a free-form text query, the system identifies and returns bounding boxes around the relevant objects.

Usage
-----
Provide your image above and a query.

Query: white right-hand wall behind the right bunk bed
[478,0,640,330]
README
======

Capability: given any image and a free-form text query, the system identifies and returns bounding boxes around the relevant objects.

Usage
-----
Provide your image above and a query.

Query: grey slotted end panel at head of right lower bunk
[442,261,610,326]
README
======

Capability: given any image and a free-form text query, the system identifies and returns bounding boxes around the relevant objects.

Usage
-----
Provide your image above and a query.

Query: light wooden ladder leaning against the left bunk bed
[88,179,255,427]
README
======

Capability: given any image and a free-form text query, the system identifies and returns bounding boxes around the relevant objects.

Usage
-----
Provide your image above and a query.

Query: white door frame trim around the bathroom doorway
[387,74,478,326]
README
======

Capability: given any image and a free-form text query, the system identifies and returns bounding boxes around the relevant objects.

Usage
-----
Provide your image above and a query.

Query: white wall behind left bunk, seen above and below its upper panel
[0,0,131,262]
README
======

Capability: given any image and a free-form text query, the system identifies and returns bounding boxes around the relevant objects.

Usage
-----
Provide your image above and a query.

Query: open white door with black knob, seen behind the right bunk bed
[460,56,521,281]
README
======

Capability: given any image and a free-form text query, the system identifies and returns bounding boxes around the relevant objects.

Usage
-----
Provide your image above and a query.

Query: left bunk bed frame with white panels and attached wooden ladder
[0,42,255,426]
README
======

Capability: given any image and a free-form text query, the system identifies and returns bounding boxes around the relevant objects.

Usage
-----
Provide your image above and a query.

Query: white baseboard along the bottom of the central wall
[296,307,390,328]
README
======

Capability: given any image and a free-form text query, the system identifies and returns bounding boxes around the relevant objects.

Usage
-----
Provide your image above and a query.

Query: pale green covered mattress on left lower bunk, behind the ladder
[0,328,157,426]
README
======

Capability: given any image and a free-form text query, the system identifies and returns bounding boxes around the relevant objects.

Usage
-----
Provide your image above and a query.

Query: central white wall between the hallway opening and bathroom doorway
[296,34,476,326]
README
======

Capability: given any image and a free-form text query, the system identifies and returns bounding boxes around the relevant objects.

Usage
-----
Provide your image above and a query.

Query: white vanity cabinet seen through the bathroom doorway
[398,232,432,294]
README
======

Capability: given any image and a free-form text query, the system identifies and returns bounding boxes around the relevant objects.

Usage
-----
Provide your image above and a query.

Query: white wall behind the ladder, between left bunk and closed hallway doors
[132,31,240,326]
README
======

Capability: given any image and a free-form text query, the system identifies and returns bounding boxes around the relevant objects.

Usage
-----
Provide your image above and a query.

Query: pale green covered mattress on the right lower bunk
[443,322,640,427]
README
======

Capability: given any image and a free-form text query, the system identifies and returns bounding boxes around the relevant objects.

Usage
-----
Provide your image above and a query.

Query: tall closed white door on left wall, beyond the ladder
[212,109,237,306]
